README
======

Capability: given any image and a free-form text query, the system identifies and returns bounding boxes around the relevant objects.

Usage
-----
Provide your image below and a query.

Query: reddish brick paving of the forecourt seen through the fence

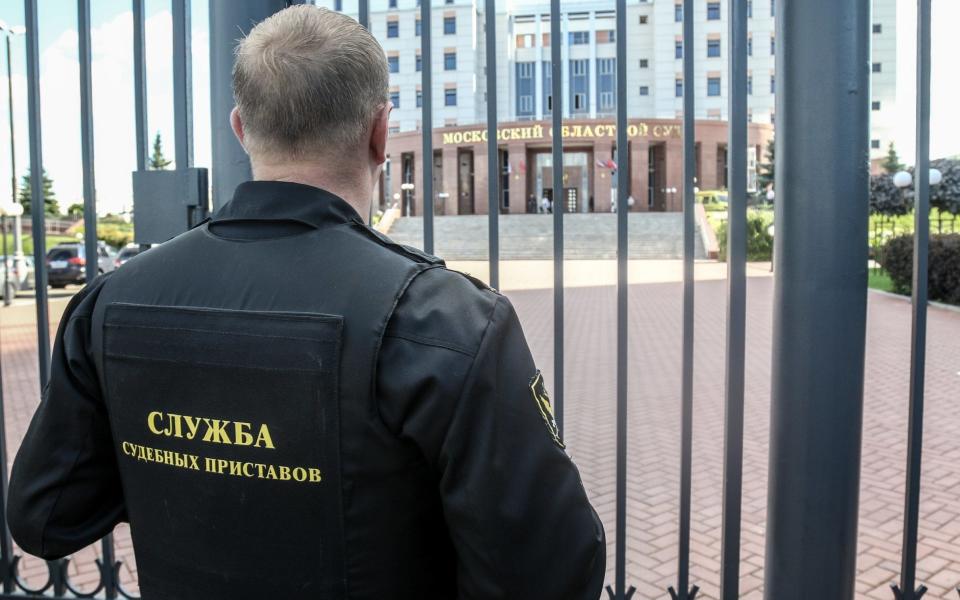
[0,265,960,600]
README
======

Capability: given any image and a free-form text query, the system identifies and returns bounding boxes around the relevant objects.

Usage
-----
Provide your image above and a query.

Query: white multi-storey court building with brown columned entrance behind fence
[315,0,897,214]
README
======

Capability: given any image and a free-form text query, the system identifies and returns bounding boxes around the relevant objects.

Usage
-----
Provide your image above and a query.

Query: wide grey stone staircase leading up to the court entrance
[387,213,706,260]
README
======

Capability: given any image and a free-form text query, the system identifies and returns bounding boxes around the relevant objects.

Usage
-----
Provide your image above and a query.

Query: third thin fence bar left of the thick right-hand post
[604,0,636,600]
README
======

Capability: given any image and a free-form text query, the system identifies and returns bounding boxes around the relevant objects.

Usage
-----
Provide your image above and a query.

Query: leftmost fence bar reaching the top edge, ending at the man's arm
[23,0,50,390]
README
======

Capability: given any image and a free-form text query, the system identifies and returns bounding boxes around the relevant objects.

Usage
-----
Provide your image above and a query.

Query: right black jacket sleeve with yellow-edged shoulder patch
[380,288,606,600]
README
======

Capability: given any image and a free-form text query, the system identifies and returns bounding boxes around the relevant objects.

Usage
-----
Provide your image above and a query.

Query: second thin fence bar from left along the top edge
[77,0,100,283]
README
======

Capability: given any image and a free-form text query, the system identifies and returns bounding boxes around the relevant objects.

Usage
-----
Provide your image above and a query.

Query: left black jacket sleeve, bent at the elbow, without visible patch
[7,280,126,559]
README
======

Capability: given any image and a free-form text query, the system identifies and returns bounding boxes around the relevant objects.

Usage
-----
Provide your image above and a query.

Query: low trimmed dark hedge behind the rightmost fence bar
[880,234,960,304]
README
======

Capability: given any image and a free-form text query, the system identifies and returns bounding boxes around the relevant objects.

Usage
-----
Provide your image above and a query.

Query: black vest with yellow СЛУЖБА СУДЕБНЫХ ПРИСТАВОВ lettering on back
[92,205,442,600]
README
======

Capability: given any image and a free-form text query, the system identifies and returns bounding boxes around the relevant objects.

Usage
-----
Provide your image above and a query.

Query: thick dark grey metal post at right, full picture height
[765,0,870,600]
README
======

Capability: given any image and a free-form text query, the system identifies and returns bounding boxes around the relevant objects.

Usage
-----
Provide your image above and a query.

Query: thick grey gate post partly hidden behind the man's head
[210,0,287,210]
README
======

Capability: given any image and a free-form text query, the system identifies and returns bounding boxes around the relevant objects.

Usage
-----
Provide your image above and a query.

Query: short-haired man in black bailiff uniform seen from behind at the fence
[8,6,605,600]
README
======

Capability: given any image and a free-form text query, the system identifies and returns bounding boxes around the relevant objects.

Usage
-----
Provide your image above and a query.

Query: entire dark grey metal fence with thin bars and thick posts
[0,0,944,600]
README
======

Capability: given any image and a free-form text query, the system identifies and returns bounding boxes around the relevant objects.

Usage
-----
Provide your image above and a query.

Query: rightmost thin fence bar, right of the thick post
[891,0,930,600]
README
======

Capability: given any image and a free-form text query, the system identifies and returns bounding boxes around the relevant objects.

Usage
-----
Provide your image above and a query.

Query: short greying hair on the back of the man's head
[233,4,389,160]
